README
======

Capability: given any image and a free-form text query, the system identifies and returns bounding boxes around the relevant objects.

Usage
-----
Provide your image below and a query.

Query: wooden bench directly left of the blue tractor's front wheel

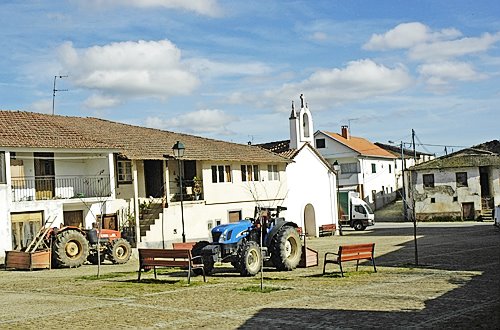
[137,249,206,284]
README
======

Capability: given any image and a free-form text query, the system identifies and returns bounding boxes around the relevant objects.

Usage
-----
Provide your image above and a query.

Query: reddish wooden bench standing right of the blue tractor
[323,243,377,277]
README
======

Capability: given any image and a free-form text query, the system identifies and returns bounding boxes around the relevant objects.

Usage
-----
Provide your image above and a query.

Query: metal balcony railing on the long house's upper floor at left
[12,176,111,202]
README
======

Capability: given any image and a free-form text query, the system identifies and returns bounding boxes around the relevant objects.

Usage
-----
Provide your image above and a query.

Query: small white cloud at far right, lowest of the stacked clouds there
[418,61,486,86]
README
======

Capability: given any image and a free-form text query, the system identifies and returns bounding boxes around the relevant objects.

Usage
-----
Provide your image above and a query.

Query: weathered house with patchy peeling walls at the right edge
[409,140,500,220]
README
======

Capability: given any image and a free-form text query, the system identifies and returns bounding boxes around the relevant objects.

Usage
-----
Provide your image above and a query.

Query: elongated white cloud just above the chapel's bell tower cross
[266,59,413,104]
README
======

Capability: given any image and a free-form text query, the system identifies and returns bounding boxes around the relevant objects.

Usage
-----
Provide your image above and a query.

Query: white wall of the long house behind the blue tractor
[140,161,288,247]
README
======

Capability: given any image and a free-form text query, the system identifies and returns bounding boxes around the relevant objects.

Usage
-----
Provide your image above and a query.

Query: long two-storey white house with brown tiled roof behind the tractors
[0,111,289,260]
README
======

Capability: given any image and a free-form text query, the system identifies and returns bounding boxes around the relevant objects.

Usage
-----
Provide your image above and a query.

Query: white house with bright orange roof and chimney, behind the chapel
[314,126,396,208]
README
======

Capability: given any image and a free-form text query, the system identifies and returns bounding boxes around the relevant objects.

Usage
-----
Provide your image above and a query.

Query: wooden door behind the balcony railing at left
[34,152,55,200]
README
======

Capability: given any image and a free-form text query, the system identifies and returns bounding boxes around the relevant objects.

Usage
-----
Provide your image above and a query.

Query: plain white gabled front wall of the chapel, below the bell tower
[285,147,338,236]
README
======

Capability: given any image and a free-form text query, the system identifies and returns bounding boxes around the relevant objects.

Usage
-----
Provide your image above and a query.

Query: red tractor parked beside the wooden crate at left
[45,226,132,268]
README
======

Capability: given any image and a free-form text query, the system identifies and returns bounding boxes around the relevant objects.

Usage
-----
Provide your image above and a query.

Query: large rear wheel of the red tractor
[52,230,89,267]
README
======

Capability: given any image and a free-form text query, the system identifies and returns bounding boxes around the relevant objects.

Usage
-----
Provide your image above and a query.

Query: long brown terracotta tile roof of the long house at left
[0,111,288,163]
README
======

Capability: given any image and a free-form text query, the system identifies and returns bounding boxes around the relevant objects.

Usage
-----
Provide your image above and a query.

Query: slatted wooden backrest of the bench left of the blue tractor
[139,249,192,267]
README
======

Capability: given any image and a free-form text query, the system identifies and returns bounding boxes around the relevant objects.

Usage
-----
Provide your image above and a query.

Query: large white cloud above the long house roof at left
[59,40,199,99]
